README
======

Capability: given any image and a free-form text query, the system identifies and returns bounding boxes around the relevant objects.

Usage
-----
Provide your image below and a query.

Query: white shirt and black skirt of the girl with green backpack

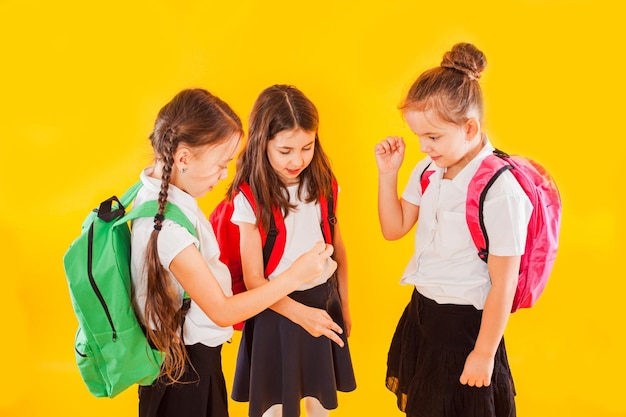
[131,168,233,417]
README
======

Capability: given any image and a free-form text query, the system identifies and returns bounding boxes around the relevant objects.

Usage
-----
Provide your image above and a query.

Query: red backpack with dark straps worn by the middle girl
[209,181,337,330]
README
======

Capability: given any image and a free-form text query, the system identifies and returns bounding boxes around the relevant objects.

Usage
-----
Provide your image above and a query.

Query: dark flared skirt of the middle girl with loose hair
[232,276,356,417]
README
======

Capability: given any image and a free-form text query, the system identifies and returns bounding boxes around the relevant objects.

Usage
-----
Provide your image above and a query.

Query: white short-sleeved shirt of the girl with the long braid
[131,168,233,346]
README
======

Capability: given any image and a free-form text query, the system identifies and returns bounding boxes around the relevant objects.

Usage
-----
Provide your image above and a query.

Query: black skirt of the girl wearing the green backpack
[139,343,228,417]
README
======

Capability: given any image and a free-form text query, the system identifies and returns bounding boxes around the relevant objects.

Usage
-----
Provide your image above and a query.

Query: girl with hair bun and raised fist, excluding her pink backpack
[375,43,532,417]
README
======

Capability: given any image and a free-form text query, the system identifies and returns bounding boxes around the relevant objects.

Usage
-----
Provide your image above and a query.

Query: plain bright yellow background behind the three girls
[0,0,626,417]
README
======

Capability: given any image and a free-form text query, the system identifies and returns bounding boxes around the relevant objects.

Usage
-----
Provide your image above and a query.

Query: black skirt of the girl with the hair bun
[386,291,516,417]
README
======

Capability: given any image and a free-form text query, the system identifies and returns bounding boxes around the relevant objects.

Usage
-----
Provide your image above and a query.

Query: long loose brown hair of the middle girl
[227,84,334,230]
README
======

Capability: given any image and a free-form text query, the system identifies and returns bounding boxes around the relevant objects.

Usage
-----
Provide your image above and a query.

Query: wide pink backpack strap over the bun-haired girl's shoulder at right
[465,154,513,262]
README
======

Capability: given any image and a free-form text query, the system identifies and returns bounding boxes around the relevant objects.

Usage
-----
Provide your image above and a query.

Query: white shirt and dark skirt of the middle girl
[231,185,356,417]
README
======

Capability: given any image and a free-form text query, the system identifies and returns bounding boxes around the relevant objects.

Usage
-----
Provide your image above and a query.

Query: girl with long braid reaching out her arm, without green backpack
[131,89,332,417]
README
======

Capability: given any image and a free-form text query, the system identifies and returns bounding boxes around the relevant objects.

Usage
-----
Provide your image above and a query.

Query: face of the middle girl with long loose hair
[267,129,316,185]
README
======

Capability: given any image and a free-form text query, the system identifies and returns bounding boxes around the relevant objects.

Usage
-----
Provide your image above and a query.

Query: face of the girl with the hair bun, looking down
[404,110,480,174]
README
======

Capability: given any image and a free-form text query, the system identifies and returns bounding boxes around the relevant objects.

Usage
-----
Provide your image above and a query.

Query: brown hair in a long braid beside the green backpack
[145,89,243,382]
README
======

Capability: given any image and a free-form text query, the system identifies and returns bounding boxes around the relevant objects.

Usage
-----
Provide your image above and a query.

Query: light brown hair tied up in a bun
[400,43,487,125]
